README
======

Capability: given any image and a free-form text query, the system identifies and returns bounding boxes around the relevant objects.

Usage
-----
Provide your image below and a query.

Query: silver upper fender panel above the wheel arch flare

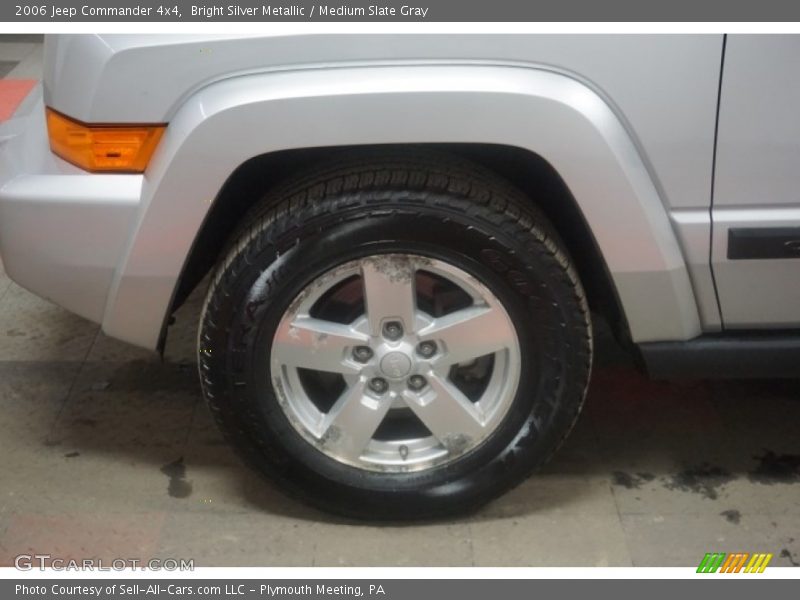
[45,34,723,216]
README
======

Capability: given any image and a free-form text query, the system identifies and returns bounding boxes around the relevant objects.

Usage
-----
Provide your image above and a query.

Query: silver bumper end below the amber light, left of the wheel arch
[0,87,143,323]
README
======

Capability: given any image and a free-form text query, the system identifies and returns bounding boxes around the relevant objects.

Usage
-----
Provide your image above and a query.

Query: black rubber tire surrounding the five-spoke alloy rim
[198,152,592,520]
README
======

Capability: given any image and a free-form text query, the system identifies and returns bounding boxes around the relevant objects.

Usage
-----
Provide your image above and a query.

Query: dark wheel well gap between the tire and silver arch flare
[164,144,629,351]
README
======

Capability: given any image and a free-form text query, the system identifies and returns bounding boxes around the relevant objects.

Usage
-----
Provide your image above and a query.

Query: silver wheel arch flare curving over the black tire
[103,65,700,348]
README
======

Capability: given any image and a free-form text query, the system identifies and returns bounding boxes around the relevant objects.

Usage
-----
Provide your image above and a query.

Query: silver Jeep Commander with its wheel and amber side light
[0,35,800,519]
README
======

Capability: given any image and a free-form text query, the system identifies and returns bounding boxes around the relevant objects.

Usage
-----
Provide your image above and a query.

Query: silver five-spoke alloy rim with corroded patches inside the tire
[270,254,520,472]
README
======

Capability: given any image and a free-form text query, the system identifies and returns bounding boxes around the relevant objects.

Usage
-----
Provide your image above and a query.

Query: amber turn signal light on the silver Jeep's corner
[47,108,167,173]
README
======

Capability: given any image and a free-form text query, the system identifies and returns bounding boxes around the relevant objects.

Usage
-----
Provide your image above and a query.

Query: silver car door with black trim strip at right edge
[711,35,800,329]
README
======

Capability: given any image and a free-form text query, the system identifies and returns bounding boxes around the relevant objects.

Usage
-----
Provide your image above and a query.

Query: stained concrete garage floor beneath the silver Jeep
[0,36,800,566]
